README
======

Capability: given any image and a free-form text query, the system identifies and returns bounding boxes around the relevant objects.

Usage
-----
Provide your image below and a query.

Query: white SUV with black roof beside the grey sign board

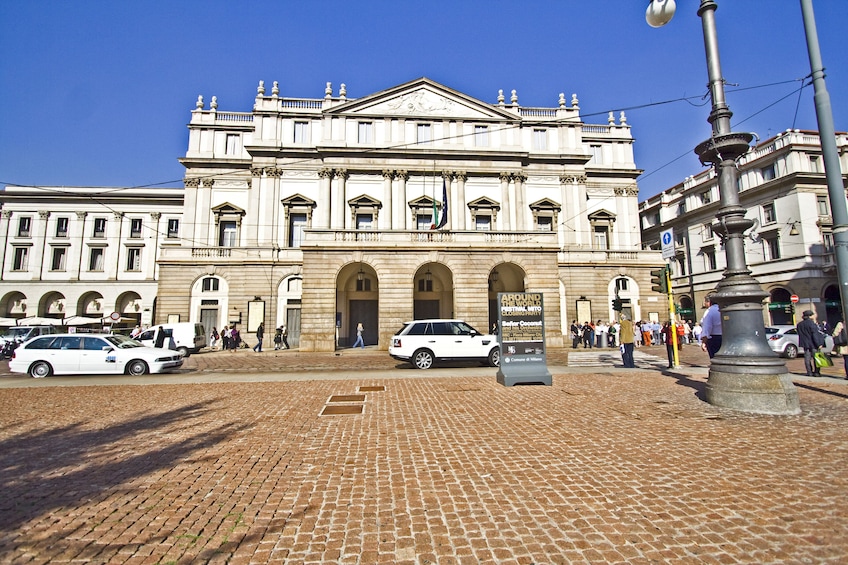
[389,320,501,369]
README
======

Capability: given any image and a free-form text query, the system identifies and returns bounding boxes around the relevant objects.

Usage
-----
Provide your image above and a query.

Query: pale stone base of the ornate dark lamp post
[706,366,801,416]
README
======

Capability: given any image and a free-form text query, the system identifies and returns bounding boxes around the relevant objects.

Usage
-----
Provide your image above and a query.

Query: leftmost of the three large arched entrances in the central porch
[336,262,380,347]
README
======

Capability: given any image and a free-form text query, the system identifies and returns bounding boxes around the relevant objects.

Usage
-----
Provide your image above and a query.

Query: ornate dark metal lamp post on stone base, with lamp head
[646,0,801,414]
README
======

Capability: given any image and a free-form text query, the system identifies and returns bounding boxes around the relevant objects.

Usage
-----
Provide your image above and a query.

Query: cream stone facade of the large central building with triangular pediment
[166,78,663,351]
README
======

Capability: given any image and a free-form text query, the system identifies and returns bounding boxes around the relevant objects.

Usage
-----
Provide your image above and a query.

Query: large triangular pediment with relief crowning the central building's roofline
[330,78,519,120]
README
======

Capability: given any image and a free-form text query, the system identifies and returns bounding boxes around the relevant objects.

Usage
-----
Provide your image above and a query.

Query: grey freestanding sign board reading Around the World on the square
[498,292,553,386]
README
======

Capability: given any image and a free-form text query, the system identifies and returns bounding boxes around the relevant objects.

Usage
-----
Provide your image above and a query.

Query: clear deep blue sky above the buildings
[0,0,848,200]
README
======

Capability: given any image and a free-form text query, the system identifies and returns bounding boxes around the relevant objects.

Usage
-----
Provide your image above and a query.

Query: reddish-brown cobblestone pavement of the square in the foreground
[0,346,848,565]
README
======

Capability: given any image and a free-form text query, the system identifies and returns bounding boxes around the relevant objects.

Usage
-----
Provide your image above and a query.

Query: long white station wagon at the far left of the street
[9,333,183,378]
